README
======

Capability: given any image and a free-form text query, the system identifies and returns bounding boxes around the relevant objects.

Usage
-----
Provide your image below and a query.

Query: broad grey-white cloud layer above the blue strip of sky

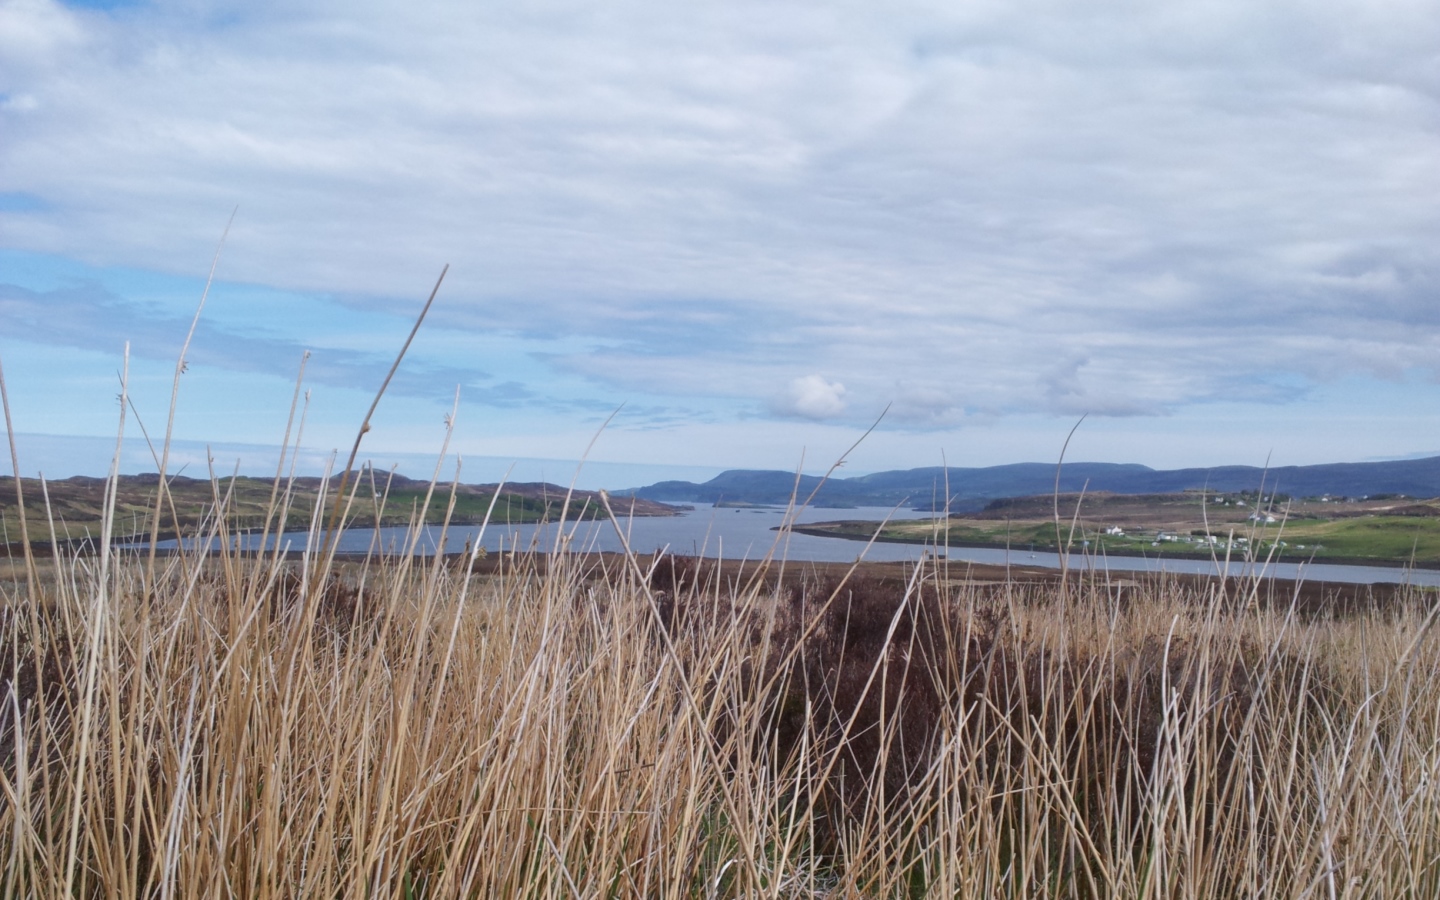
[0,0,1440,466]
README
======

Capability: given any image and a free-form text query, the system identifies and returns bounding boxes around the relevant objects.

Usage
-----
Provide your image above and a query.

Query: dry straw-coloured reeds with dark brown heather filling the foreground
[0,488,1440,899]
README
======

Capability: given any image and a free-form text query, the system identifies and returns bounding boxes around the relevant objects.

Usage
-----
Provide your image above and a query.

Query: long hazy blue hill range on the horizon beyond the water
[616,456,1440,510]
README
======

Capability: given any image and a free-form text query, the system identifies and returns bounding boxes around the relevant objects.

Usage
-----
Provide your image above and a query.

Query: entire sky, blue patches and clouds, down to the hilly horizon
[0,0,1440,487]
